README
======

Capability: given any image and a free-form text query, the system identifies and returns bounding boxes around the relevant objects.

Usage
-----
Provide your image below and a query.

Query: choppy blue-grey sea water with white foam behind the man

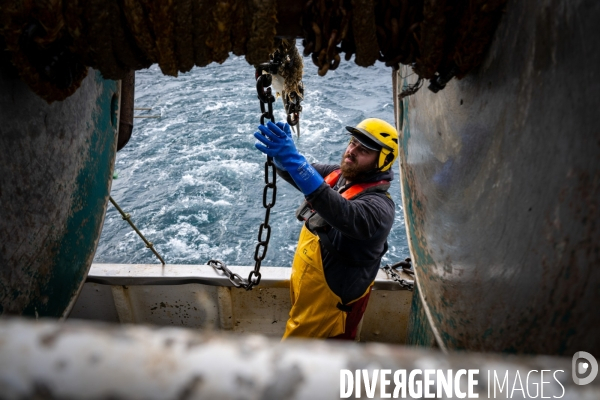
[94,51,409,267]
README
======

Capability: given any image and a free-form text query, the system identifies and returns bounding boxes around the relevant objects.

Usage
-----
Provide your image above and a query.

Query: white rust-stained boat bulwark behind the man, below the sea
[69,264,412,344]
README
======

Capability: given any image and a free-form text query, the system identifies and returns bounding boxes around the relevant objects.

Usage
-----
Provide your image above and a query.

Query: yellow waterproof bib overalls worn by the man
[283,226,371,339]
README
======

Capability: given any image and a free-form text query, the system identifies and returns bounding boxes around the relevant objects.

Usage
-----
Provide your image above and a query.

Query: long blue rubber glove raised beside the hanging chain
[254,121,323,196]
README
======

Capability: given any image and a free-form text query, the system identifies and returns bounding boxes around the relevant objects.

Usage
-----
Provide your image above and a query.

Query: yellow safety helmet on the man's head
[346,118,398,171]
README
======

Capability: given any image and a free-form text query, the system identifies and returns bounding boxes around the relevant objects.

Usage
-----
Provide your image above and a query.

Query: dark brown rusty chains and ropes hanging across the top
[0,0,506,102]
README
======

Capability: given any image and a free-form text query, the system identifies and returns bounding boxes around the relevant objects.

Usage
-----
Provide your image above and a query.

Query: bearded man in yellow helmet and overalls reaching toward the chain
[254,118,398,340]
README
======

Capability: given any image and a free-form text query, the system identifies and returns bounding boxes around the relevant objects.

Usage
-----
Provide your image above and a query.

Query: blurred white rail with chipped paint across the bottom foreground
[0,319,600,400]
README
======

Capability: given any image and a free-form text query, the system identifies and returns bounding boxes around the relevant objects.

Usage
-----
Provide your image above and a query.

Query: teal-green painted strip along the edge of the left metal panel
[23,74,118,316]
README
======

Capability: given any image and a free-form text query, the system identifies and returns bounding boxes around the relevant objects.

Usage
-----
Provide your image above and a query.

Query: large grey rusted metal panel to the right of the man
[396,1,600,355]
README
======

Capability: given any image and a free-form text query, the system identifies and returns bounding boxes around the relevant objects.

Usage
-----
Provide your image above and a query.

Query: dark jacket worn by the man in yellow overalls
[277,164,395,304]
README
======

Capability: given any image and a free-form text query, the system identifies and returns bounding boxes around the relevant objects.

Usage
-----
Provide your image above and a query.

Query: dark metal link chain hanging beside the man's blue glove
[208,70,277,290]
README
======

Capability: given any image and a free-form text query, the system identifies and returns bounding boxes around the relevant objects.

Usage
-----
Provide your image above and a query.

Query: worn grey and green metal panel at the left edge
[0,68,119,317]
